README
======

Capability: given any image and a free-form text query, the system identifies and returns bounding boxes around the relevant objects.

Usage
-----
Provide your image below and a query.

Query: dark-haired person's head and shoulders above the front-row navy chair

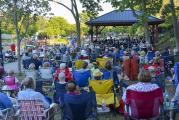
[66,82,80,95]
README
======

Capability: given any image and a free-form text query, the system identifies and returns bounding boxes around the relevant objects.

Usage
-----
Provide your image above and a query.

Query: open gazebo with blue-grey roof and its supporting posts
[86,10,164,41]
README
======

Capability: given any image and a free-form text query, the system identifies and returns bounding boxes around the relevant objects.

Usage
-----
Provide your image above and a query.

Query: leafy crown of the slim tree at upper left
[0,0,50,40]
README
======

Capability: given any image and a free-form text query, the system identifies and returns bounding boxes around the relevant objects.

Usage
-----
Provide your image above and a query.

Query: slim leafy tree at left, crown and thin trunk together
[0,0,50,73]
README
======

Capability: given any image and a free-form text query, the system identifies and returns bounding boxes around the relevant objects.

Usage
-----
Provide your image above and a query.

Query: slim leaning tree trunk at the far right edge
[170,0,179,52]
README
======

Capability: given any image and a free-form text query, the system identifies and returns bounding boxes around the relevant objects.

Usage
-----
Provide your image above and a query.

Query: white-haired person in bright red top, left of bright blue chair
[54,63,72,82]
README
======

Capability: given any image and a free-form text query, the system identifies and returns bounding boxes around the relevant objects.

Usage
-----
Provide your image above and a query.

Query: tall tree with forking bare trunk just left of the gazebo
[49,0,101,46]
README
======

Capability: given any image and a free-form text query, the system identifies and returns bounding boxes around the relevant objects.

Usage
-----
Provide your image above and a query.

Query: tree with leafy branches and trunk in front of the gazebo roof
[107,0,162,42]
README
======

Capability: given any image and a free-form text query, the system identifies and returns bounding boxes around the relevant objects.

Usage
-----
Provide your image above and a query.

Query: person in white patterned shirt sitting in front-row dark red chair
[122,69,159,102]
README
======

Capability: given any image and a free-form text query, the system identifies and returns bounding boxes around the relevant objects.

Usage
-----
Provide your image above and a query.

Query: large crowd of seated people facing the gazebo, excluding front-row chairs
[0,38,179,119]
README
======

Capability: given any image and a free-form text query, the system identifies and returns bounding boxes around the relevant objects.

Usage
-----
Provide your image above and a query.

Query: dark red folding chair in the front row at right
[125,88,164,119]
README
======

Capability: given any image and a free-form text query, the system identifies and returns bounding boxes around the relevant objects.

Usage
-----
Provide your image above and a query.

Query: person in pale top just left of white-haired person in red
[39,62,53,80]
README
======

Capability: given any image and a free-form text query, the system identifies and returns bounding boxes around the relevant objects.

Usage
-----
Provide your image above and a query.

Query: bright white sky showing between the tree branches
[50,0,113,23]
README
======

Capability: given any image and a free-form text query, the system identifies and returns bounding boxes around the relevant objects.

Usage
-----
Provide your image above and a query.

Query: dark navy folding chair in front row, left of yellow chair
[63,92,97,120]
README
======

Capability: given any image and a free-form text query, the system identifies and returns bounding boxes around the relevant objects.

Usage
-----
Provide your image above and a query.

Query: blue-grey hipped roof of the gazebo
[86,10,164,26]
